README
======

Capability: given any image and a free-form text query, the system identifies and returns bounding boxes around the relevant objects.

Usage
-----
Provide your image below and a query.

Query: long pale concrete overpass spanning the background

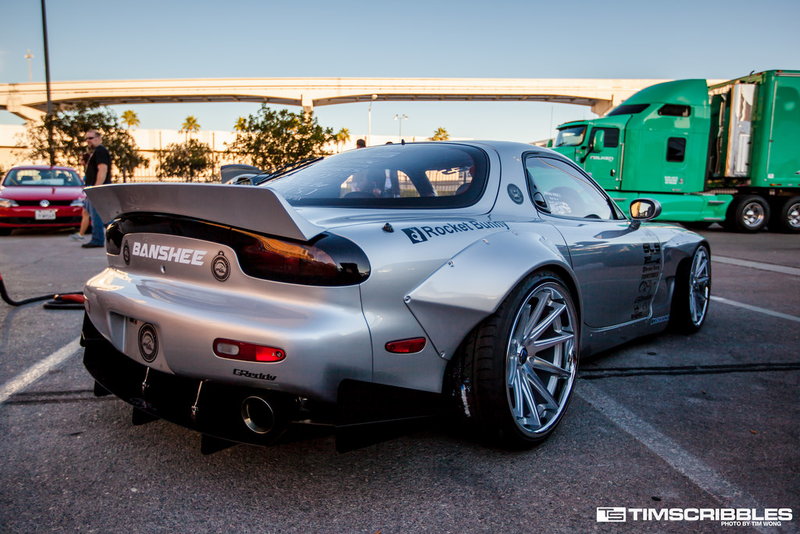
[0,78,667,120]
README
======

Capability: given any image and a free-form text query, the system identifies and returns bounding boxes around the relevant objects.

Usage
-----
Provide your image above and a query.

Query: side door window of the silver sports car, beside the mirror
[525,156,615,219]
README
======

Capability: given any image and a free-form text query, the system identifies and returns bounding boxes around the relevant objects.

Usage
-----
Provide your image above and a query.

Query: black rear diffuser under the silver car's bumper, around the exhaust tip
[81,316,441,452]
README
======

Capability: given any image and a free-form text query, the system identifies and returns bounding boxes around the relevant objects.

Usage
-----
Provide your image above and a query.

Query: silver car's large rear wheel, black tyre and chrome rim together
[453,272,579,448]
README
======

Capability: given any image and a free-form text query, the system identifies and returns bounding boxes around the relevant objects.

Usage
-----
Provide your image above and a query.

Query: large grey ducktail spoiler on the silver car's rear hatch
[85,183,324,241]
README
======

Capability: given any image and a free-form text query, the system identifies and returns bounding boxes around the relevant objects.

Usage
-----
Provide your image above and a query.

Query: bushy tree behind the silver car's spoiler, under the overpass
[228,104,333,170]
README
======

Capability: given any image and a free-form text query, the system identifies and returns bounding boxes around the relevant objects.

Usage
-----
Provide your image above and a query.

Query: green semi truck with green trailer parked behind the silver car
[553,70,800,232]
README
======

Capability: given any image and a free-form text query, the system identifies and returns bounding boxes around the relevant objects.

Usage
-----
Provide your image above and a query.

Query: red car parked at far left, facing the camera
[0,165,85,235]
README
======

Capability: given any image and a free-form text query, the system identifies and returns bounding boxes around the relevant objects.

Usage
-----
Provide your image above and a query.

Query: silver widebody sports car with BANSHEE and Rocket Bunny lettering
[82,142,711,451]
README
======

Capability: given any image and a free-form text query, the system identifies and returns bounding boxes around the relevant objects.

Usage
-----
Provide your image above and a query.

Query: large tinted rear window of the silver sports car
[264,143,489,208]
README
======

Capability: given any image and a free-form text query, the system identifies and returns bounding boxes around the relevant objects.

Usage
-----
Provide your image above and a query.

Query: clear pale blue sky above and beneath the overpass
[0,0,800,141]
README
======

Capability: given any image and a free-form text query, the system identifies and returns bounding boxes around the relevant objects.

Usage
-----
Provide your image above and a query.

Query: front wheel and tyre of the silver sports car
[670,245,711,334]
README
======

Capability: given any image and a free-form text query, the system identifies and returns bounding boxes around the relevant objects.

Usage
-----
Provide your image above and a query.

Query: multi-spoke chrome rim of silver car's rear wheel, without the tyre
[506,282,578,437]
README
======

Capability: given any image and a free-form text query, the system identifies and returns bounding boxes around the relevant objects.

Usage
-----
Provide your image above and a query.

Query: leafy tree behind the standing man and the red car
[26,104,148,180]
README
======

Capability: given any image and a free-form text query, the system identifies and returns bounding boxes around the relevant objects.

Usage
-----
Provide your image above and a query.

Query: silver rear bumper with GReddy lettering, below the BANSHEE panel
[84,265,372,402]
